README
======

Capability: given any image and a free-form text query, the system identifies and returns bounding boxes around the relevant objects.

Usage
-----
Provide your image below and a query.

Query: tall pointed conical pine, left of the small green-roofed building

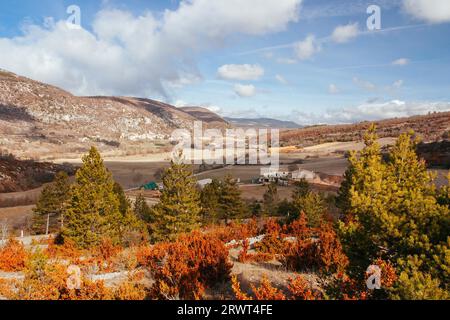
[62,147,123,248]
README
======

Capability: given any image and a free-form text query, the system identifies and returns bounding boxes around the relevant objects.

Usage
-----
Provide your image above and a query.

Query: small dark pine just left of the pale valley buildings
[219,175,246,220]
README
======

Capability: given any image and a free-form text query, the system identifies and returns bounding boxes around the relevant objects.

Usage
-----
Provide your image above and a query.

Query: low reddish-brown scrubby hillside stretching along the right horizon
[280,112,450,147]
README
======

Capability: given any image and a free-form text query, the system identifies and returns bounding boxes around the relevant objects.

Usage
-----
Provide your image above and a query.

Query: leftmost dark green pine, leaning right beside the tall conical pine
[32,172,70,234]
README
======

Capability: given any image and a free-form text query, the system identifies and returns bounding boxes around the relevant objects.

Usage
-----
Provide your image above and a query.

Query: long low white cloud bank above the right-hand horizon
[295,100,450,125]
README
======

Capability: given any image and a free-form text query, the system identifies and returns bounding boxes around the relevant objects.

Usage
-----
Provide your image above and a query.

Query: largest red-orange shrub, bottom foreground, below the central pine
[146,231,232,299]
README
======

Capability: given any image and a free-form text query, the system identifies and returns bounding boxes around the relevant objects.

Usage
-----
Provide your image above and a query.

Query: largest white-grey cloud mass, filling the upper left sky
[0,0,302,96]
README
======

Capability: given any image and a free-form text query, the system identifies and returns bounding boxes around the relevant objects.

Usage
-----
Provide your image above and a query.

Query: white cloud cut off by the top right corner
[403,0,450,23]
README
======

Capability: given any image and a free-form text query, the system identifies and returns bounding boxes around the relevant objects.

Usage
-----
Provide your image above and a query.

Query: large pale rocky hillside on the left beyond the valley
[0,71,227,159]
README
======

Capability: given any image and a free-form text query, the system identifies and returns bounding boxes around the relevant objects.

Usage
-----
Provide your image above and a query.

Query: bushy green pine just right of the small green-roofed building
[151,161,201,241]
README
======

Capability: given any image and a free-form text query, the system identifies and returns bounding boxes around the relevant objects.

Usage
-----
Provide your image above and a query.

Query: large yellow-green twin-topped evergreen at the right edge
[340,128,450,298]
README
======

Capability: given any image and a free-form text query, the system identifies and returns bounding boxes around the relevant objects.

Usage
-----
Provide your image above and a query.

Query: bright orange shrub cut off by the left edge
[0,239,27,272]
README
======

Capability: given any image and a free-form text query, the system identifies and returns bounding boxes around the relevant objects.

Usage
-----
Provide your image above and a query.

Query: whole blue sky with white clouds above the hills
[0,0,450,125]
